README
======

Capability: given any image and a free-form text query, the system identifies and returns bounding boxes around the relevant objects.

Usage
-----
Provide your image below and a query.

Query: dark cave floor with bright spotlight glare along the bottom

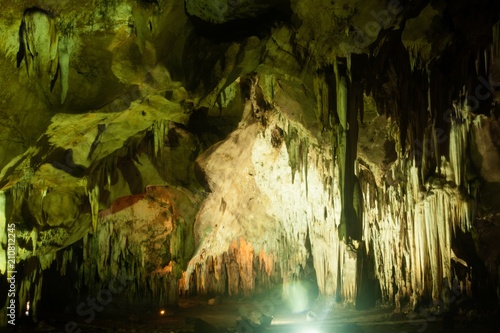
[0,297,500,333]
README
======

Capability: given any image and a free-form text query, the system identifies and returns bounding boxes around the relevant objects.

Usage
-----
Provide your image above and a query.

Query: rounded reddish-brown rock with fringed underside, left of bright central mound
[74,186,196,306]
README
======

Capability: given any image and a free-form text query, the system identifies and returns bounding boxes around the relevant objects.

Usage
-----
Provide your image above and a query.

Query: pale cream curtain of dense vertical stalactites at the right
[364,97,474,308]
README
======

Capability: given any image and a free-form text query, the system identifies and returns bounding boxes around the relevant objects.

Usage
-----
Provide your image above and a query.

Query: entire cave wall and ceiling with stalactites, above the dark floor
[0,0,500,324]
